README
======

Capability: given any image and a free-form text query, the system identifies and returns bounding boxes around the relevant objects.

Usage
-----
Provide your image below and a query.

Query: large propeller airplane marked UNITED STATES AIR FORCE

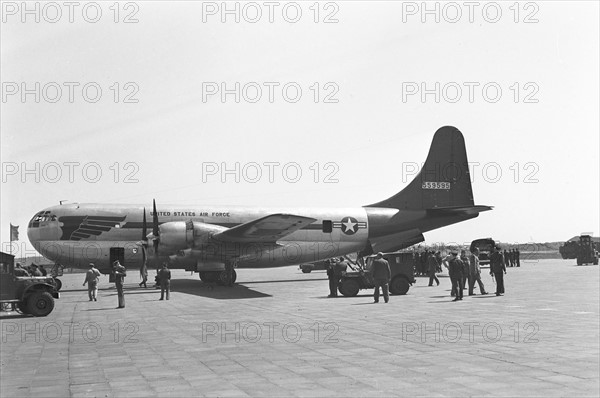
[27,126,492,285]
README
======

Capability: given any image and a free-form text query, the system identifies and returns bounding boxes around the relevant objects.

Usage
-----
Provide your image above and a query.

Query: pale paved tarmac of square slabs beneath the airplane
[0,260,600,397]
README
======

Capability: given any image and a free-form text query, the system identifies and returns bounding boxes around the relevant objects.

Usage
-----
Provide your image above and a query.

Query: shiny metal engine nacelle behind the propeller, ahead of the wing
[158,221,227,253]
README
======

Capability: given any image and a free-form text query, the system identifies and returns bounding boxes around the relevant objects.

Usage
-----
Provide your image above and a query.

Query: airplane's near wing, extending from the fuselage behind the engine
[213,214,317,243]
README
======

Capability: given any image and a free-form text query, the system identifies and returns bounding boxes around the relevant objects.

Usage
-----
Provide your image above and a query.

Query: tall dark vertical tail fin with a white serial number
[367,126,474,210]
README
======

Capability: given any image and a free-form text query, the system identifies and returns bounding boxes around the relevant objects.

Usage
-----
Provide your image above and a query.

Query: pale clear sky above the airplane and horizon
[0,1,600,258]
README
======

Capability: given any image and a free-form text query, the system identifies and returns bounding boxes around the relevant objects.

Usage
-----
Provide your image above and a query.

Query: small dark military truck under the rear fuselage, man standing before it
[338,252,415,297]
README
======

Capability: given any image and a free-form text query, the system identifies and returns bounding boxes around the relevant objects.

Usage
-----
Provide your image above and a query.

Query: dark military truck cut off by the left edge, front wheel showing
[0,252,59,316]
